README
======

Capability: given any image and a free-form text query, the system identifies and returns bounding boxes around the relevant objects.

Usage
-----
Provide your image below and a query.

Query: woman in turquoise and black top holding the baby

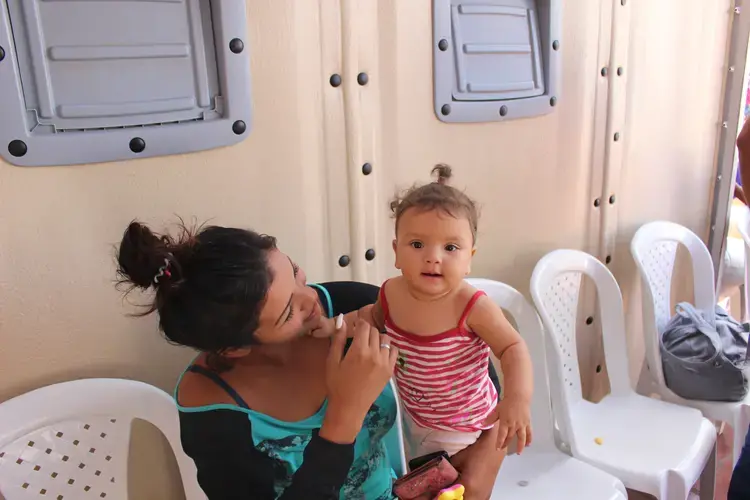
[118,222,505,500]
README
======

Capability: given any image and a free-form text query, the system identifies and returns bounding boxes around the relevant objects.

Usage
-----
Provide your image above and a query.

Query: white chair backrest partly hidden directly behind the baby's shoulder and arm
[466,278,555,448]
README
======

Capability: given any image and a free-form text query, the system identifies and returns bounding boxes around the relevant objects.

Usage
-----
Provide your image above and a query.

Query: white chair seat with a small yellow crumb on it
[572,394,716,495]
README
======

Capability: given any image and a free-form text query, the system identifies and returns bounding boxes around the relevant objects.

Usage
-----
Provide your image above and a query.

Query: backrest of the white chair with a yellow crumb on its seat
[531,250,632,446]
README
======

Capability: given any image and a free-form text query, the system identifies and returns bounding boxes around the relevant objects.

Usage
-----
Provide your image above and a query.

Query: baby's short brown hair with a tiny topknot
[391,164,479,243]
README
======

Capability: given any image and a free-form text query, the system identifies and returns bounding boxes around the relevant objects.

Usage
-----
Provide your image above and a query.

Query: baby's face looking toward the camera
[393,208,474,296]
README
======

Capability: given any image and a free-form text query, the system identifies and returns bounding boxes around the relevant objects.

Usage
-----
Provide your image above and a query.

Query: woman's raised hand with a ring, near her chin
[320,318,398,444]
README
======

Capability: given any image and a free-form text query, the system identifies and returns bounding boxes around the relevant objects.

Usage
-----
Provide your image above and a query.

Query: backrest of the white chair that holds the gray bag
[630,221,716,386]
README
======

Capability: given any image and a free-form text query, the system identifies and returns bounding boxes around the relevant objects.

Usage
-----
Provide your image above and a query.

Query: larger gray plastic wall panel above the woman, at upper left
[0,0,252,166]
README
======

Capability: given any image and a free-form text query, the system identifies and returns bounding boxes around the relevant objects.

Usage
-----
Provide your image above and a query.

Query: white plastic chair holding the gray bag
[630,221,750,463]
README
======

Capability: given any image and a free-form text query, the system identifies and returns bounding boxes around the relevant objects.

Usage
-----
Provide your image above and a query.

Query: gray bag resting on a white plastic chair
[659,302,749,401]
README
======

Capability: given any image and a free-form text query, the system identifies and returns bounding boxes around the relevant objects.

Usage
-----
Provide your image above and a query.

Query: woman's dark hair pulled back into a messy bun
[117,222,276,369]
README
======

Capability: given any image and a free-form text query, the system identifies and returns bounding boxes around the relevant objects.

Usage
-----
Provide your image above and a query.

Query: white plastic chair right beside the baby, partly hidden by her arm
[467,278,627,500]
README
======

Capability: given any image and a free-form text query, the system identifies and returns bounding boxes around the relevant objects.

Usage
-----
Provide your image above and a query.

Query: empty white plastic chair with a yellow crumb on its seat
[531,250,716,500]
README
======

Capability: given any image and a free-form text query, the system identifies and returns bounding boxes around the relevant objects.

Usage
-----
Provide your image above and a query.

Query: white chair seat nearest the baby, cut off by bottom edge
[491,444,627,500]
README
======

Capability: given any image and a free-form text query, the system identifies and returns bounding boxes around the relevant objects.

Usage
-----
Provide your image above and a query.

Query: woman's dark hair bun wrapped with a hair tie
[117,221,172,289]
